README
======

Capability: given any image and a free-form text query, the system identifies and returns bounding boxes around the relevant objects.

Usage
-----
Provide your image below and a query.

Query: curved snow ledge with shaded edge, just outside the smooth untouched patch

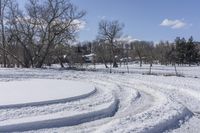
[0,82,119,132]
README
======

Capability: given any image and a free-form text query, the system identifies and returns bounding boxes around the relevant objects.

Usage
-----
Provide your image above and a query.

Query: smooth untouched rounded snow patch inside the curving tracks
[0,79,95,108]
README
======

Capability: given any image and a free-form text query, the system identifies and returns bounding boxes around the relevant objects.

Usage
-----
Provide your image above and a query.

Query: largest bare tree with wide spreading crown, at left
[6,0,85,68]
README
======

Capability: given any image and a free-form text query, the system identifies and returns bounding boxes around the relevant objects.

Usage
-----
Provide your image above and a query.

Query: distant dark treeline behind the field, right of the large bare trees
[76,37,200,67]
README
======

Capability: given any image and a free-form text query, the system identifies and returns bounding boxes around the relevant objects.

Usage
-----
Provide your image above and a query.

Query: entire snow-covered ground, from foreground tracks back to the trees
[0,65,200,133]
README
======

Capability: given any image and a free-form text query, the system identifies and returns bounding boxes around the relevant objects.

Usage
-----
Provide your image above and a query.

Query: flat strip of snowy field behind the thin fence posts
[85,63,200,77]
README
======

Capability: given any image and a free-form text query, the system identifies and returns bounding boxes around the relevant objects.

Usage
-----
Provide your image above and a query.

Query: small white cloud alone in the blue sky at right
[160,19,187,29]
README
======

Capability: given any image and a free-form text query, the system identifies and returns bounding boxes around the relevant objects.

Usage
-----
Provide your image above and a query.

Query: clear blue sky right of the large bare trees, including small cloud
[16,0,200,42]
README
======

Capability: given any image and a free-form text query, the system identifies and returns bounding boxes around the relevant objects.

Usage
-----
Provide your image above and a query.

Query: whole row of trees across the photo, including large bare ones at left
[0,0,200,68]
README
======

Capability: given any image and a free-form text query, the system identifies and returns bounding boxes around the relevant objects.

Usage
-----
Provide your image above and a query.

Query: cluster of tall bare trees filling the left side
[0,0,85,68]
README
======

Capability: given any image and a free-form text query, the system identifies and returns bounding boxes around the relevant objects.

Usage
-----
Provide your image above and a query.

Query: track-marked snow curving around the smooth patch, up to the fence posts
[0,69,200,133]
